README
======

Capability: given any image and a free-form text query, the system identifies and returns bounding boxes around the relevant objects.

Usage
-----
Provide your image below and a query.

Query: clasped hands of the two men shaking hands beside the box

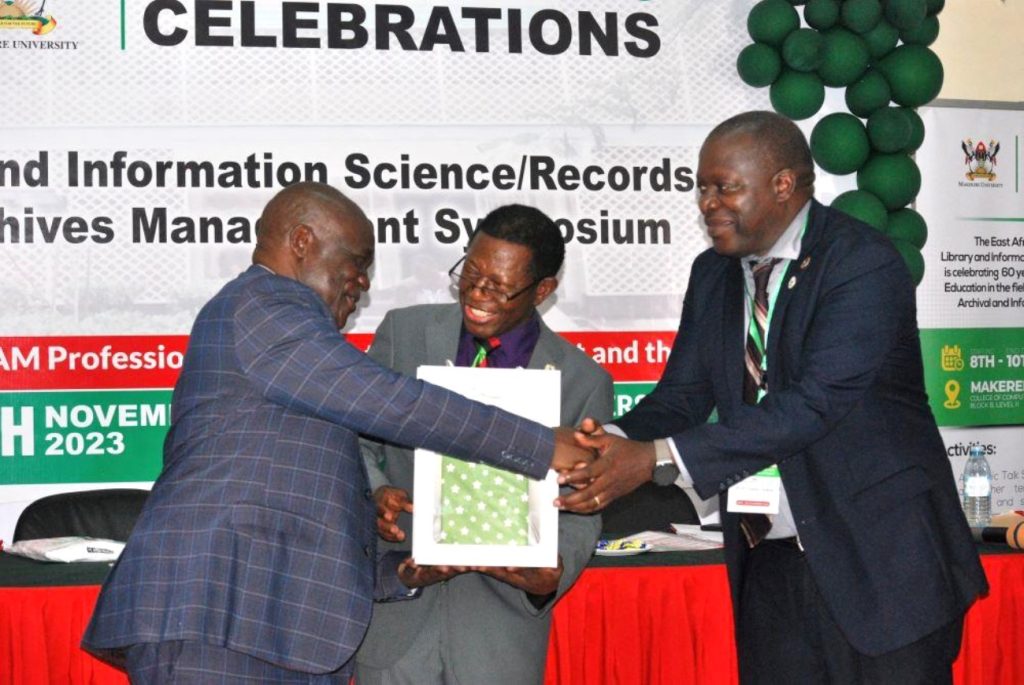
[551,419,655,514]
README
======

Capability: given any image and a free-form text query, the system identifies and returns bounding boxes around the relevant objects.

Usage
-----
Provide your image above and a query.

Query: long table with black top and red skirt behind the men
[0,546,1024,685]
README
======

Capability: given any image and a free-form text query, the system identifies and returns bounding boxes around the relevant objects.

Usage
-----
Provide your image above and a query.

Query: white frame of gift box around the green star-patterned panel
[413,367,561,568]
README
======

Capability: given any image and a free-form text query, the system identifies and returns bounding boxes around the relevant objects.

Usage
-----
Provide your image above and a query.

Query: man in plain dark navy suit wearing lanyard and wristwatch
[560,112,986,684]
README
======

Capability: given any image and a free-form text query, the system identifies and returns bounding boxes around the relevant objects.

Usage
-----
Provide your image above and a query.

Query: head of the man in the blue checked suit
[253,183,374,328]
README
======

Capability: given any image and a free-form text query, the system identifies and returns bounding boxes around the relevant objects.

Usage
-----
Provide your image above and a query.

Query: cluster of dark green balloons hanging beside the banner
[736,0,945,283]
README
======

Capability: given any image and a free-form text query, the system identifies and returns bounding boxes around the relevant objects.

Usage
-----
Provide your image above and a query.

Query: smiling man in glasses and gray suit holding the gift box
[356,205,612,685]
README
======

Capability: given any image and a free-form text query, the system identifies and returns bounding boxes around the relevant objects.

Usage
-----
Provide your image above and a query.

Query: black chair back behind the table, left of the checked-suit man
[14,487,150,543]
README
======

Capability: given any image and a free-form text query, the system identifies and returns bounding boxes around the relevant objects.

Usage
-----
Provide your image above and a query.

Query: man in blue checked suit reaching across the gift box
[83,183,590,683]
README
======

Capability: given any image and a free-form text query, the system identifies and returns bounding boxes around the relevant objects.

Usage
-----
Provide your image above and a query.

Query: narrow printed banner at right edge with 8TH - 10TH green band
[916,103,1024,512]
